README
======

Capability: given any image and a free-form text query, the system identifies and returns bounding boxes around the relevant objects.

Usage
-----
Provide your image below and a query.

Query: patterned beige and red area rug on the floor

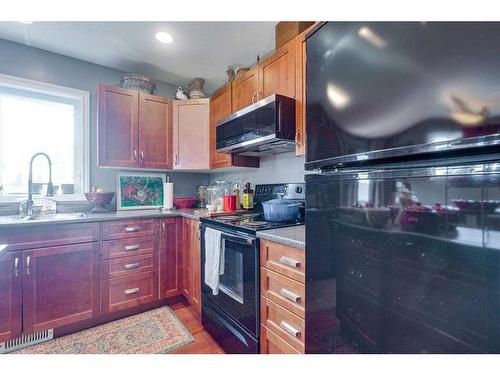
[15,306,194,354]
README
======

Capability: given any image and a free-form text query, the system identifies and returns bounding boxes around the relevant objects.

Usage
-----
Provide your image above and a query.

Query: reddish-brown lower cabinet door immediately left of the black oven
[181,218,201,314]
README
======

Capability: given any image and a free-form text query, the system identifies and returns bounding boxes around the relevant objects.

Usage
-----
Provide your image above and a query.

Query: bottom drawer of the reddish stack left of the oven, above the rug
[101,272,158,313]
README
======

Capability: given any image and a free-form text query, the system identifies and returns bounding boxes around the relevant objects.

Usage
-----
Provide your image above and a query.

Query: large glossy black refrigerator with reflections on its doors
[306,22,500,353]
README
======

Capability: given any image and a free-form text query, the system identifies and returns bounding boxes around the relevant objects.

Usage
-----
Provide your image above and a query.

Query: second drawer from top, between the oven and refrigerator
[260,267,306,319]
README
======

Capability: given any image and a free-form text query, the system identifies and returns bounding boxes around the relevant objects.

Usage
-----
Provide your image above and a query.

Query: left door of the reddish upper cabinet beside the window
[97,84,139,167]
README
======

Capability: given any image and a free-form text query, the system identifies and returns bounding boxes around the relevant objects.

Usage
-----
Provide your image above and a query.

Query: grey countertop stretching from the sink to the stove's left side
[0,208,215,229]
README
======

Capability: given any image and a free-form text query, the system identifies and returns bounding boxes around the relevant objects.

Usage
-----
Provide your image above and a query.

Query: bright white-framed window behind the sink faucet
[0,75,89,196]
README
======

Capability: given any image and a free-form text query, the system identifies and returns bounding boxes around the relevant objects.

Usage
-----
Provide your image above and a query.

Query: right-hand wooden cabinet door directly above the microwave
[258,41,295,100]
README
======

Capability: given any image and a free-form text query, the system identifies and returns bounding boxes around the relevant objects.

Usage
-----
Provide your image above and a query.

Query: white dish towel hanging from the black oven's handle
[205,228,224,295]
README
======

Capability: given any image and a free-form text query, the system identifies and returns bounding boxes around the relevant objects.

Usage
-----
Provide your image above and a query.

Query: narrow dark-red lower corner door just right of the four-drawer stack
[159,218,183,298]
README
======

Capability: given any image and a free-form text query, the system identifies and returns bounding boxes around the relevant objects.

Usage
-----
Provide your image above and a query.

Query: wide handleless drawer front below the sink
[0,223,99,251]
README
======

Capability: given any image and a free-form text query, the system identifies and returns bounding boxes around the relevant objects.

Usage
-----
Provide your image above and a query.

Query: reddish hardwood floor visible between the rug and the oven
[169,302,224,354]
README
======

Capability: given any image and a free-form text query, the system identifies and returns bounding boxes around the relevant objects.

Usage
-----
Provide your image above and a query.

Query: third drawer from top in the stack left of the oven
[101,253,158,279]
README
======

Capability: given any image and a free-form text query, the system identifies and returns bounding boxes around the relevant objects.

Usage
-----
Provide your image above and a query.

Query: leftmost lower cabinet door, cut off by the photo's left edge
[0,252,23,342]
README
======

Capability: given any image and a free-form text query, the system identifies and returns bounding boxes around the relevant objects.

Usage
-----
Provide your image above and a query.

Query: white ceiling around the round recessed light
[0,22,276,92]
